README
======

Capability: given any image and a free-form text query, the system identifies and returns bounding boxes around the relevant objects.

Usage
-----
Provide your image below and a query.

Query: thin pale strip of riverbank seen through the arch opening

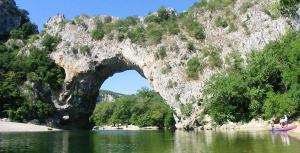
[93,125,159,131]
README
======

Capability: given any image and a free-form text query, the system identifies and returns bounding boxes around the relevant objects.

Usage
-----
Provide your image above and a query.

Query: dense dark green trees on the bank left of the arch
[0,11,64,121]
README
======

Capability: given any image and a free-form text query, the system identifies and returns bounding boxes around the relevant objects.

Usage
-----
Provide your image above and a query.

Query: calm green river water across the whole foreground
[0,131,300,153]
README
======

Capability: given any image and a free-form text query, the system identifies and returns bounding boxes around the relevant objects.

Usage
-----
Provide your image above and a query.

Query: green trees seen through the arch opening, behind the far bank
[91,89,175,129]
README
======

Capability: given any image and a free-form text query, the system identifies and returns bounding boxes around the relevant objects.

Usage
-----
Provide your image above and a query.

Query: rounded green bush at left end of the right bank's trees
[204,73,250,124]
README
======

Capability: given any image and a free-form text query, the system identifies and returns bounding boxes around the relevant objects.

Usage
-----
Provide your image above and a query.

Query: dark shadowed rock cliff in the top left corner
[0,0,22,40]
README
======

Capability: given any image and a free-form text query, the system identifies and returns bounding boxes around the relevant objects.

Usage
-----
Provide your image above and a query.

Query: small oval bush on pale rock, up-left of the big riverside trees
[186,57,204,80]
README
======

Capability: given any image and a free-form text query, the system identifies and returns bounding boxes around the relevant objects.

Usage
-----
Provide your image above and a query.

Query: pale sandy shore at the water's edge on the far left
[0,121,59,132]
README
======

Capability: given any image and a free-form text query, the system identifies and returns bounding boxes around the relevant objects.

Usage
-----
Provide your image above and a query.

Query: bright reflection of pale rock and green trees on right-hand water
[174,131,299,153]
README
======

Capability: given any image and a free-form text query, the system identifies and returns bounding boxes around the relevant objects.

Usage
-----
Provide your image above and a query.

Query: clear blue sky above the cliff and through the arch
[16,0,199,94]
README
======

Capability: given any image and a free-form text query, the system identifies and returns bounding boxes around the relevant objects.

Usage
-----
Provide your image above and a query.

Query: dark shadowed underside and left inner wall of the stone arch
[55,54,149,128]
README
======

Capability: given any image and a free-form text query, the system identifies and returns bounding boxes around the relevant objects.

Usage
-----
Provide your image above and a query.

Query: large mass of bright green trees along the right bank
[204,32,300,123]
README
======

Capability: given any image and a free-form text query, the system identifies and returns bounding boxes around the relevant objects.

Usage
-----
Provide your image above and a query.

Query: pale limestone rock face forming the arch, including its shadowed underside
[33,0,299,128]
